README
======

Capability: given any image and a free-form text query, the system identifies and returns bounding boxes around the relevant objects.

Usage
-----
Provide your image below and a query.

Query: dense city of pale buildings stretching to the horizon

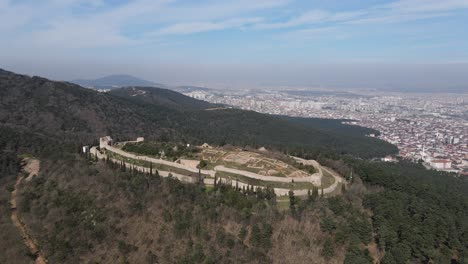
[185,90,468,175]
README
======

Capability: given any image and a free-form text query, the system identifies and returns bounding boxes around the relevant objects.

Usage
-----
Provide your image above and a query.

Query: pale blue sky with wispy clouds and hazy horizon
[0,0,468,91]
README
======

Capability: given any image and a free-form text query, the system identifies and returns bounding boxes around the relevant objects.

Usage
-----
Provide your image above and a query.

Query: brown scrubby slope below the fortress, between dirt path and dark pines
[15,157,344,264]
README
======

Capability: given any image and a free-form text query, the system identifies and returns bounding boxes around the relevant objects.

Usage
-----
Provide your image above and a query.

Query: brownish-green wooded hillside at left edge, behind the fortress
[0,71,187,141]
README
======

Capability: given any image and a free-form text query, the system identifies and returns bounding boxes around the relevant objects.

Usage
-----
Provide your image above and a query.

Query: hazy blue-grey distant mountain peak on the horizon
[71,74,165,90]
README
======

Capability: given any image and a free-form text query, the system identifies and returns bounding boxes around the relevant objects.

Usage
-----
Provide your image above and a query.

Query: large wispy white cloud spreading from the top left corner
[0,0,290,49]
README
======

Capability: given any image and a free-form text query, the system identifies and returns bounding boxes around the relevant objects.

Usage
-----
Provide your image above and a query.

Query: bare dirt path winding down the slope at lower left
[10,159,47,264]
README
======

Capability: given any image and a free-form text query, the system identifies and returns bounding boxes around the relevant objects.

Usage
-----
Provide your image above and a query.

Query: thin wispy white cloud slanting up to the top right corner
[260,0,468,43]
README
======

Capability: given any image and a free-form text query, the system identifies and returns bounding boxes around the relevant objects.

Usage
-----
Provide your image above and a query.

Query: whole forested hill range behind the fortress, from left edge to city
[0,71,396,157]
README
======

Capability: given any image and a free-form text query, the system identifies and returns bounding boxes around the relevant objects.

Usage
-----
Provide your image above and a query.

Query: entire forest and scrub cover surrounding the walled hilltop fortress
[0,71,468,264]
